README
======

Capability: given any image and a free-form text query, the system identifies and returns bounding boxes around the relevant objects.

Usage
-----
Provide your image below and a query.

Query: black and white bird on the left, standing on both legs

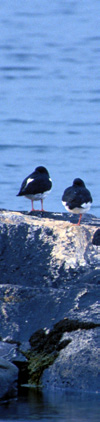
[17,166,52,211]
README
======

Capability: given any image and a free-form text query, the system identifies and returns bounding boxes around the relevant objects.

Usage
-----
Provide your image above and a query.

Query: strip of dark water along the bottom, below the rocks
[0,390,100,422]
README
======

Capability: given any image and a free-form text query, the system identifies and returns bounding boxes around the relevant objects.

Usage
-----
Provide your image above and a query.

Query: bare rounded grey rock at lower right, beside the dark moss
[41,329,100,393]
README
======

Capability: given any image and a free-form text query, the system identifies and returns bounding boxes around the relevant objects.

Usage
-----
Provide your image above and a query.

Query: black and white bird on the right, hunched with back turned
[62,178,92,225]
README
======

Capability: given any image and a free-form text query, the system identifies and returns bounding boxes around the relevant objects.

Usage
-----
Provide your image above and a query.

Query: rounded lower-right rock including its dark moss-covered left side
[22,318,100,391]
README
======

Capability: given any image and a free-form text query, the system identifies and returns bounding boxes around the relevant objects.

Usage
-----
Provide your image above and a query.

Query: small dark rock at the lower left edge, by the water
[0,358,18,399]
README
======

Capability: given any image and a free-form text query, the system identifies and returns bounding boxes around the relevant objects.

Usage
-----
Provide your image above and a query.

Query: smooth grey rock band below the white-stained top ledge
[0,269,100,343]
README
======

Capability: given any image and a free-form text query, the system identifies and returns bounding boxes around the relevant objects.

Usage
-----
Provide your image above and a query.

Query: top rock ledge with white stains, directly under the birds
[0,211,99,291]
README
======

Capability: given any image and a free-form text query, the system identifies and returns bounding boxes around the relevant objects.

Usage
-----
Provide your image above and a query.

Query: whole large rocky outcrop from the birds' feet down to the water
[0,210,100,398]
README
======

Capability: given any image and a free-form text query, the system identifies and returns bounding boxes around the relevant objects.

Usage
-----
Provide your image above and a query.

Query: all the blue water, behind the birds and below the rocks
[0,0,100,422]
